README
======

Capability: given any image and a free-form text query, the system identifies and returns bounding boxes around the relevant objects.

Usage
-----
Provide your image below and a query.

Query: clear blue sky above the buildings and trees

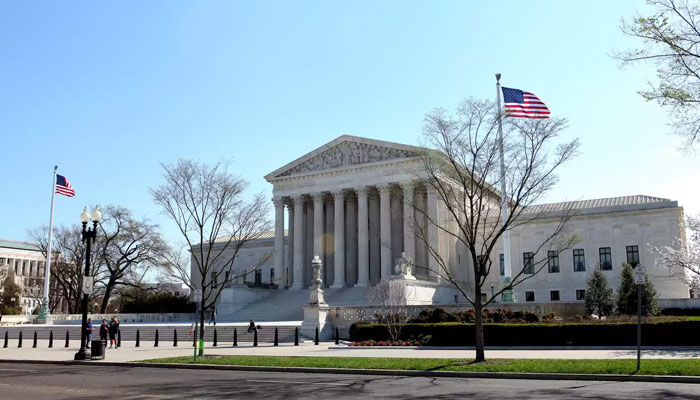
[0,0,700,244]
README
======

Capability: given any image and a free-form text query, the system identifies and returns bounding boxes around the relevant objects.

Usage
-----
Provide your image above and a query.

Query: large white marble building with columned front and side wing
[191,136,689,320]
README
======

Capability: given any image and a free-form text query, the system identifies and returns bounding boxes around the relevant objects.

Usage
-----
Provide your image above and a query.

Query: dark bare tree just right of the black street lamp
[95,206,166,313]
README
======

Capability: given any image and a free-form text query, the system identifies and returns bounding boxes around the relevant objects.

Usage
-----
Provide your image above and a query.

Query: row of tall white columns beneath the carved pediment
[273,183,438,289]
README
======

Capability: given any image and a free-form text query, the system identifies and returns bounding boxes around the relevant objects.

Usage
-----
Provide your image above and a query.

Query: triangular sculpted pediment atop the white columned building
[265,135,421,180]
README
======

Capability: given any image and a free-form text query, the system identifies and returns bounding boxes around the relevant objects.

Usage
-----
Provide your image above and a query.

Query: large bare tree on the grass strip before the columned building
[414,99,578,362]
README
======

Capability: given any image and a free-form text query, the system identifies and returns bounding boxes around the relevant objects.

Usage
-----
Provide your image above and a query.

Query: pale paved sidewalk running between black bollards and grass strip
[0,340,700,362]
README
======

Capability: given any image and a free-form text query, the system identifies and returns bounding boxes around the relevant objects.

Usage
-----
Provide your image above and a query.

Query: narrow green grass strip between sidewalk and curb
[142,356,700,376]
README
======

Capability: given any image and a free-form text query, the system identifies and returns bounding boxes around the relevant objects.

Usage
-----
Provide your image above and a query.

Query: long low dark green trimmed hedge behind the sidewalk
[350,321,700,346]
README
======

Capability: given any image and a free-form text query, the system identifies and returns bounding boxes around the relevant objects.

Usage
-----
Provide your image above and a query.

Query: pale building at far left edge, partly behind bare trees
[0,239,46,315]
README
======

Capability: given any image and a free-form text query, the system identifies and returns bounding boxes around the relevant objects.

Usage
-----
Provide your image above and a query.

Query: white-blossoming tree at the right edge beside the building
[651,215,700,293]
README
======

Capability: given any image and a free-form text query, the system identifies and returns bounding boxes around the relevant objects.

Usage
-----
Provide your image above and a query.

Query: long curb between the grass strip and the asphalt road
[0,360,700,384]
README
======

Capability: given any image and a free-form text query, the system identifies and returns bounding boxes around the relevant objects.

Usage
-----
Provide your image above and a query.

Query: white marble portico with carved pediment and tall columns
[265,136,438,289]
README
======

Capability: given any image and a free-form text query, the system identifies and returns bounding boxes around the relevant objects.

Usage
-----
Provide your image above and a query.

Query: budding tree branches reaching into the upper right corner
[614,0,700,148]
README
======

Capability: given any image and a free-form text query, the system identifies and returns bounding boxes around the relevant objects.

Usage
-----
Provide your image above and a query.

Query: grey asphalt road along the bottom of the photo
[0,363,700,400]
